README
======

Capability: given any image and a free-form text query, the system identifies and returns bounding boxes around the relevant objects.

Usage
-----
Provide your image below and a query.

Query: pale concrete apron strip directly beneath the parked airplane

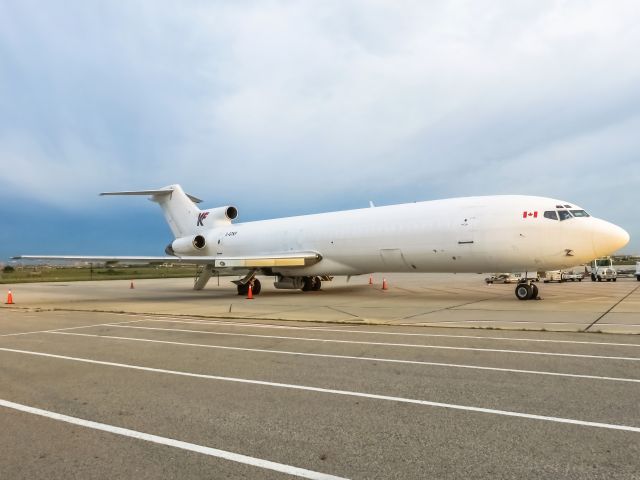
[1,274,640,334]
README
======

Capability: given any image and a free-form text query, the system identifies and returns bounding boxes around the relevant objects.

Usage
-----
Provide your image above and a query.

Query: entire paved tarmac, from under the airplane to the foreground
[0,275,640,479]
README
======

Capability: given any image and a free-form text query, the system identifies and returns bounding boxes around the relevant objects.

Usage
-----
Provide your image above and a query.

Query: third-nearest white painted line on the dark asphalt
[51,332,640,383]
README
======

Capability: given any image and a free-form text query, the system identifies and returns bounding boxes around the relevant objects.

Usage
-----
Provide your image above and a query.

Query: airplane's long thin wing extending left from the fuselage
[12,252,322,270]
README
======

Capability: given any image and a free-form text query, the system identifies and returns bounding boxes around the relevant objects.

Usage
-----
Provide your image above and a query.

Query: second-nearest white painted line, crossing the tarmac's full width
[0,348,640,433]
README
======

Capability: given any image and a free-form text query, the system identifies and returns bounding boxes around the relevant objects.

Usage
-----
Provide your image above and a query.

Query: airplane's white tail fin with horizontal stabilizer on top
[100,184,202,238]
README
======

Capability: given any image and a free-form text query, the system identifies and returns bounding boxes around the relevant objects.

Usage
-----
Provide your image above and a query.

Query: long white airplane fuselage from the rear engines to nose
[192,195,628,275]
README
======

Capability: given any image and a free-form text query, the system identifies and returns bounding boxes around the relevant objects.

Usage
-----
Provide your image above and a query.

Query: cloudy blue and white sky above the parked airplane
[0,0,640,260]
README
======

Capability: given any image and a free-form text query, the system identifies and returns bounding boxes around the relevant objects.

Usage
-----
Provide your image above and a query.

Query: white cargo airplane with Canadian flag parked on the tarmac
[14,185,629,300]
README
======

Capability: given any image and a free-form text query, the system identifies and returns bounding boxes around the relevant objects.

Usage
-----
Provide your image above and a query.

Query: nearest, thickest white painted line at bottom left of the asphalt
[0,399,343,480]
